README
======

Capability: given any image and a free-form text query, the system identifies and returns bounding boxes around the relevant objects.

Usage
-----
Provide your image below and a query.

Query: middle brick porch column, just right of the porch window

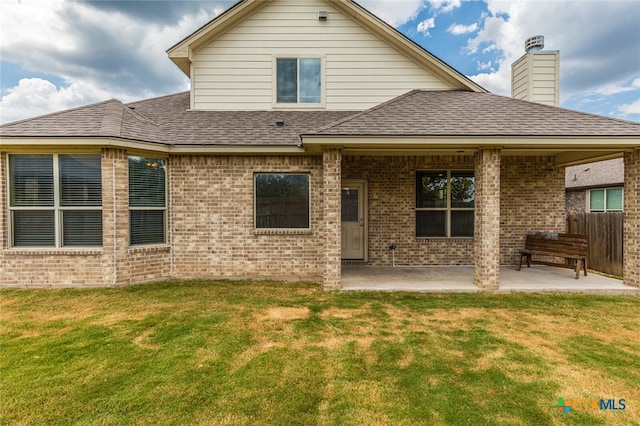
[474,148,500,290]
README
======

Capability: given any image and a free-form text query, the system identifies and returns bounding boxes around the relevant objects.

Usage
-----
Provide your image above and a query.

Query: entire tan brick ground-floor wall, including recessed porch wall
[0,148,568,289]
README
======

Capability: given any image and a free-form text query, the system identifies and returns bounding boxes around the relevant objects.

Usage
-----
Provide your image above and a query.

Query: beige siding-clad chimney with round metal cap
[511,36,560,106]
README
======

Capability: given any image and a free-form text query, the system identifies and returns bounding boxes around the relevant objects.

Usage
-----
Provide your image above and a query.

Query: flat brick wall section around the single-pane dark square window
[169,156,324,279]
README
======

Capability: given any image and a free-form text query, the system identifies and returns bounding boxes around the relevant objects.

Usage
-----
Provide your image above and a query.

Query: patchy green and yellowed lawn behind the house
[0,281,640,425]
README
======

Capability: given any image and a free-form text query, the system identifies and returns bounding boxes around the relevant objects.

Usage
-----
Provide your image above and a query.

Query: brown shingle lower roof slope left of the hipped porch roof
[0,92,354,146]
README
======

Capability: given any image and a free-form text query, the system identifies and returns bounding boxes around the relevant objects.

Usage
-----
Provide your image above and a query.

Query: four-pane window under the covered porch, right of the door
[416,170,475,238]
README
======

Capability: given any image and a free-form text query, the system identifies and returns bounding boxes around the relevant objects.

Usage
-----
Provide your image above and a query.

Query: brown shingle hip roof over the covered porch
[317,90,640,136]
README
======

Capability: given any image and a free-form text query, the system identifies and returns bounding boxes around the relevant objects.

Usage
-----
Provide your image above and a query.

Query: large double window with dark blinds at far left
[9,154,102,247]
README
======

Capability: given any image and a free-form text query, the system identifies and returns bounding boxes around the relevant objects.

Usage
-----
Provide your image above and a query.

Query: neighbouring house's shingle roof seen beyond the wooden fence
[565,158,624,189]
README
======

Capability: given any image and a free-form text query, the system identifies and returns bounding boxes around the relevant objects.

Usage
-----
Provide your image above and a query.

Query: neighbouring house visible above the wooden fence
[565,158,624,212]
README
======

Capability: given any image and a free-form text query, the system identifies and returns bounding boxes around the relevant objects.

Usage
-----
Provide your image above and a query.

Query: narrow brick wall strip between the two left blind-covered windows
[102,148,129,285]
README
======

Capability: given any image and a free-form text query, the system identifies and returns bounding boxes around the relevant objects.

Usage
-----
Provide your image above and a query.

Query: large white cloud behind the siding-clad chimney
[467,0,640,102]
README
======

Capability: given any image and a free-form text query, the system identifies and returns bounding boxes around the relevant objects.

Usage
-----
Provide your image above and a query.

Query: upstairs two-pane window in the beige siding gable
[276,58,322,104]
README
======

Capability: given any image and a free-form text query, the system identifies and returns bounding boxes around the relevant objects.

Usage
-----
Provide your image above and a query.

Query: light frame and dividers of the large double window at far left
[6,152,104,250]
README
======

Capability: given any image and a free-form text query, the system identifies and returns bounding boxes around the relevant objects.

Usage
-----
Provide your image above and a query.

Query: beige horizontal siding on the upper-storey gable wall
[191,0,452,110]
